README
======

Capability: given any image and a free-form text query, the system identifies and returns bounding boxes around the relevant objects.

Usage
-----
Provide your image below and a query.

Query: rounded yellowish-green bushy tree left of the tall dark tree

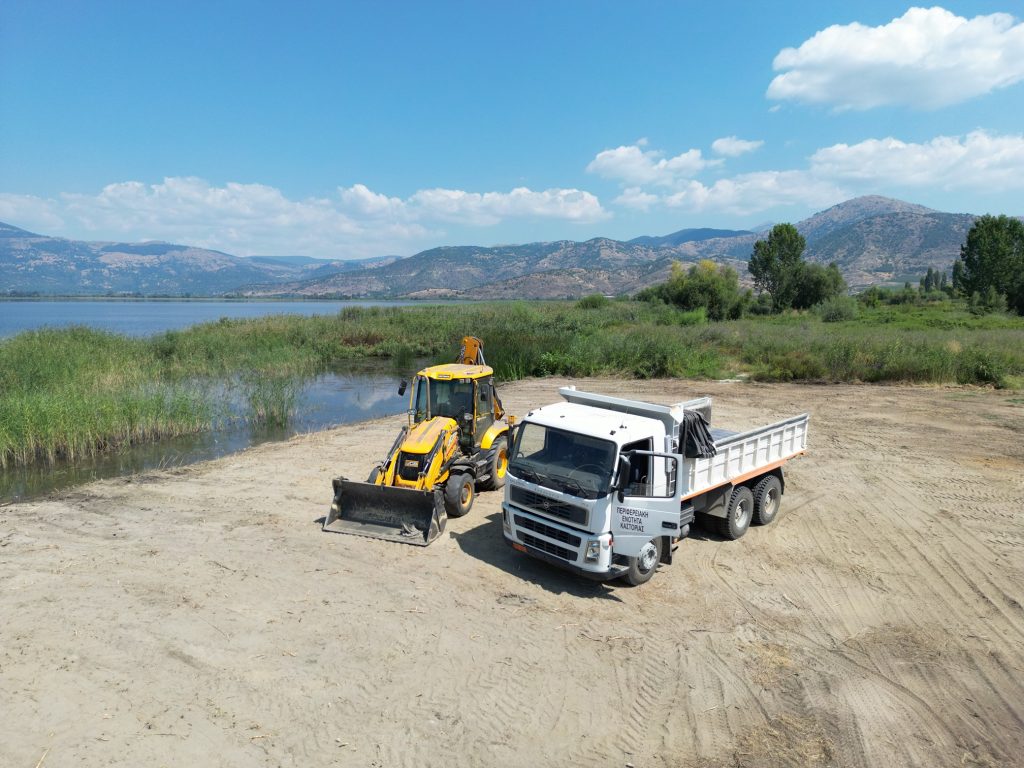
[637,260,754,321]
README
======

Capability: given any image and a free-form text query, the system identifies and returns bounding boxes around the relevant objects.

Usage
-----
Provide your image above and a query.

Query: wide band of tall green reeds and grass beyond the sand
[0,299,1024,473]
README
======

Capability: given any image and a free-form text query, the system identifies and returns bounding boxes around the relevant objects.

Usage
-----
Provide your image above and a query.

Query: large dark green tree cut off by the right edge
[953,216,1024,314]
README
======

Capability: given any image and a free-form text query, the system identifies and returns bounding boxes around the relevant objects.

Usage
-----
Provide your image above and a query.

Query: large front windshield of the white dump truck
[509,422,615,499]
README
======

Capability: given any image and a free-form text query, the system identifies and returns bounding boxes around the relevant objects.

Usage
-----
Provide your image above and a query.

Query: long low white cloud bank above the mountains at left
[0,177,608,258]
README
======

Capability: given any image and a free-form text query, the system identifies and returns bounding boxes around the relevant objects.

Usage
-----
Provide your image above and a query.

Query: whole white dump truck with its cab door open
[502,387,809,585]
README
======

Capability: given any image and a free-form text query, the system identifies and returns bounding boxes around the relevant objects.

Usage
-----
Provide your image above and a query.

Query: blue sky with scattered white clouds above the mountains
[0,0,1024,258]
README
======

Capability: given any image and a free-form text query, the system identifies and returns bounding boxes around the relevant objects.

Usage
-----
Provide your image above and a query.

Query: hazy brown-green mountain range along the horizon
[0,196,995,299]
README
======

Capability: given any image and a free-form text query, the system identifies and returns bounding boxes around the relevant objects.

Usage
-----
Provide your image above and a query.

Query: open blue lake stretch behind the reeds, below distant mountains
[0,299,452,338]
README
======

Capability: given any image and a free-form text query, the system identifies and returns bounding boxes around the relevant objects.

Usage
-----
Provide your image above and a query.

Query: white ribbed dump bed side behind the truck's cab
[683,414,810,499]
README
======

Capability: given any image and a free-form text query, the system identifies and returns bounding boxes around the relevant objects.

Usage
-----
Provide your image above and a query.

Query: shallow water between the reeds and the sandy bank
[0,366,417,502]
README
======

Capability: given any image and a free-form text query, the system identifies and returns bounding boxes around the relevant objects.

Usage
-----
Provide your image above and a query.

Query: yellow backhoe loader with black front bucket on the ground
[324,336,514,546]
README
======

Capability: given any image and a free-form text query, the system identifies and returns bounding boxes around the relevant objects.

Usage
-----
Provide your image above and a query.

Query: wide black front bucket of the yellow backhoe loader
[324,477,447,547]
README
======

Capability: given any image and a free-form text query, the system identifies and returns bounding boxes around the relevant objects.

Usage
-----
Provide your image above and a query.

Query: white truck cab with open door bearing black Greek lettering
[503,393,692,580]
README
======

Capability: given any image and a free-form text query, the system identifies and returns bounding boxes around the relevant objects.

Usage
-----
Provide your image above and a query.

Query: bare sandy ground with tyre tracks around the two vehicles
[0,380,1024,768]
